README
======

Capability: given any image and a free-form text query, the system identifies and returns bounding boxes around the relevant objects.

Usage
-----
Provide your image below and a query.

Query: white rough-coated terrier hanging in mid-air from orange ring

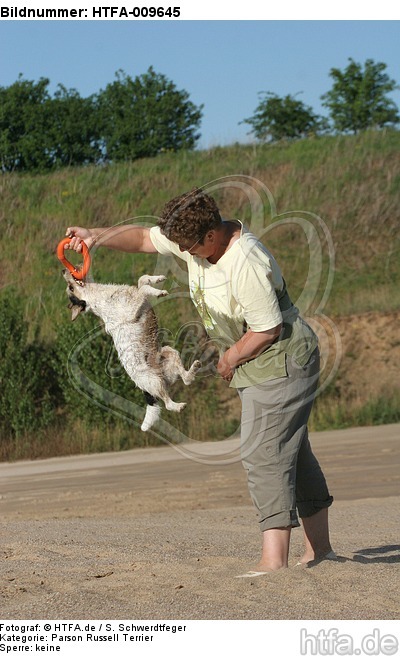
[63,271,200,431]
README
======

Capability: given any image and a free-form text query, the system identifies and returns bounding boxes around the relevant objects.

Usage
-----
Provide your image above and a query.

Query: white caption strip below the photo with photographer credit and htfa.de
[0,620,400,656]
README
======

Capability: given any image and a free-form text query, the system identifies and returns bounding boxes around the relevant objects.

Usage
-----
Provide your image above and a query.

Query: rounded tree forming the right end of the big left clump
[98,67,203,161]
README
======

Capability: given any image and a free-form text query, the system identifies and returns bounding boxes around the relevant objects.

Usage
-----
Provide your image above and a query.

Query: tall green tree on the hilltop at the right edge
[321,58,400,133]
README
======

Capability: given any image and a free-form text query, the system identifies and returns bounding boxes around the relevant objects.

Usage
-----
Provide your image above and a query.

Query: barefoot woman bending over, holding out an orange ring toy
[67,189,336,577]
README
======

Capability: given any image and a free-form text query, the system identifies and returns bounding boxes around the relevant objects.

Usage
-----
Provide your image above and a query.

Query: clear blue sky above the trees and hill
[0,20,400,148]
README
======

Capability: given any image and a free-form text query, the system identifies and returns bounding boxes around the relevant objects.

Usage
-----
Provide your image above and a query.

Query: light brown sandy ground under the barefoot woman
[0,425,400,620]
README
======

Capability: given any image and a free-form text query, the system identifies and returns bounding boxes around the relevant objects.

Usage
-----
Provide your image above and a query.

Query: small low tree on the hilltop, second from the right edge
[241,92,326,141]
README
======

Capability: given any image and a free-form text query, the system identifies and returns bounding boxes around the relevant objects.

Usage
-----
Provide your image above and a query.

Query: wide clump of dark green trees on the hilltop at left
[0,68,203,172]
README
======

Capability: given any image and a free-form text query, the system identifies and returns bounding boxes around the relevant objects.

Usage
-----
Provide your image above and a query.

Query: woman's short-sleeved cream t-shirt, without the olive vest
[150,224,284,349]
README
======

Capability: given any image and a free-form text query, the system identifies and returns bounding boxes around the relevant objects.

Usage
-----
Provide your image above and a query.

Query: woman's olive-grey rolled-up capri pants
[238,349,333,531]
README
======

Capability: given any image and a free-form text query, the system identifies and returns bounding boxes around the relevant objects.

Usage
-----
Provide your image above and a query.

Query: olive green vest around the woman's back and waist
[229,281,318,388]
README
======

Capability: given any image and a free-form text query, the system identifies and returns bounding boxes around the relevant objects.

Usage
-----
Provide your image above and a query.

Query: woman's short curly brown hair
[158,187,222,244]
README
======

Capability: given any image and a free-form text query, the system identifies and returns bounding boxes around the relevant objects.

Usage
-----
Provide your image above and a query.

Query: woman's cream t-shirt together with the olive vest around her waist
[150,222,318,388]
